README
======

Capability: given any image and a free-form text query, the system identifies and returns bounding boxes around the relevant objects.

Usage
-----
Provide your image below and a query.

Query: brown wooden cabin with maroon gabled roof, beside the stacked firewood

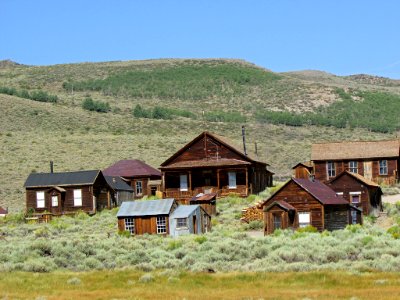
[262,178,362,234]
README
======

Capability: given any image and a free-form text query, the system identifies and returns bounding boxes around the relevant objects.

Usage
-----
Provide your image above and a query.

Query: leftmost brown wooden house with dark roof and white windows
[24,170,111,215]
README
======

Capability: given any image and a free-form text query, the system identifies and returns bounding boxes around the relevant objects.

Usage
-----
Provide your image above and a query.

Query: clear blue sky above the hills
[0,0,400,79]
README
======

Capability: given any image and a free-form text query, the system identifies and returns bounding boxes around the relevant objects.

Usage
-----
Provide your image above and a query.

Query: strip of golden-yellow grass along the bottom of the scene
[0,269,400,300]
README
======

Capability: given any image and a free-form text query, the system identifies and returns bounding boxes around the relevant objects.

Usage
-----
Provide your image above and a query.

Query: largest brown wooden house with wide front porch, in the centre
[160,131,272,203]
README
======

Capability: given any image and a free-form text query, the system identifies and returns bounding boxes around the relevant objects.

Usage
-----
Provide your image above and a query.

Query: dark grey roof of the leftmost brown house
[24,170,101,187]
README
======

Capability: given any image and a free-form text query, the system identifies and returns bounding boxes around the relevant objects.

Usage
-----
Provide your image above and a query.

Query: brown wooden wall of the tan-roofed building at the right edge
[314,158,399,185]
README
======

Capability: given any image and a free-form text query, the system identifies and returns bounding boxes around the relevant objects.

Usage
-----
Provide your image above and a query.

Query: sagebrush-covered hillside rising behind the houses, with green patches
[0,59,400,211]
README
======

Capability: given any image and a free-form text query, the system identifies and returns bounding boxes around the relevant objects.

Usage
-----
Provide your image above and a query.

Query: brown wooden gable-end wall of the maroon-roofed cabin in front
[263,181,324,231]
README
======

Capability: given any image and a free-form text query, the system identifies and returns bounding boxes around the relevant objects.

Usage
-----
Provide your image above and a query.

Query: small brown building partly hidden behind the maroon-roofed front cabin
[328,171,382,216]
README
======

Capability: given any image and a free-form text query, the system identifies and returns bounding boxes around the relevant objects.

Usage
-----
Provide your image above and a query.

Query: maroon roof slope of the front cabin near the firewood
[292,178,349,205]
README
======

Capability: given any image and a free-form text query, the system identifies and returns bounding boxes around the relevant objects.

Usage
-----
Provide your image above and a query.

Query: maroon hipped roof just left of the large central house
[103,159,161,178]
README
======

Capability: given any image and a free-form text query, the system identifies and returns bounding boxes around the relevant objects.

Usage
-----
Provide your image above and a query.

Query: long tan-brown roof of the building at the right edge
[311,140,400,161]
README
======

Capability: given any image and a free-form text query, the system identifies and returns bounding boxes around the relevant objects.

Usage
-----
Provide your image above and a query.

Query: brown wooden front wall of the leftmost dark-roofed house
[26,186,95,214]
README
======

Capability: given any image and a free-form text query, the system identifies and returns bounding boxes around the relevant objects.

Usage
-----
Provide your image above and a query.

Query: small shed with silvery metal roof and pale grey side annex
[117,199,211,236]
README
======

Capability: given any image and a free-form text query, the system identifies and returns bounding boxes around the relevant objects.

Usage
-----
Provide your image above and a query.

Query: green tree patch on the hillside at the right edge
[255,89,400,133]
